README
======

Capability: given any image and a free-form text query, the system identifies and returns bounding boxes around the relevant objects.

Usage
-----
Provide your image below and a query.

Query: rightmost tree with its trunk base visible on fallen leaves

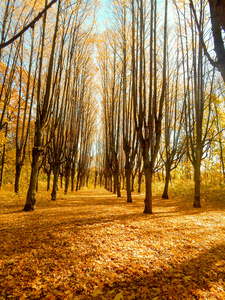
[179,2,214,207]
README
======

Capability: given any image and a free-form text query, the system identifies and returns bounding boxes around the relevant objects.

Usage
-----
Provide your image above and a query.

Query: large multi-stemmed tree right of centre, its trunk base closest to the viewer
[131,0,168,214]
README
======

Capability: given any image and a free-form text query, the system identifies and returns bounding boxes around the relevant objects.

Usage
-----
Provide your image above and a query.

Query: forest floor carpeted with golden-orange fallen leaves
[0,189,225,300]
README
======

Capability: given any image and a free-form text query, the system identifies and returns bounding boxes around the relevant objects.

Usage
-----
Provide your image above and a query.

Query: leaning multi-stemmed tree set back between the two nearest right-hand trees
[161,25,186,199]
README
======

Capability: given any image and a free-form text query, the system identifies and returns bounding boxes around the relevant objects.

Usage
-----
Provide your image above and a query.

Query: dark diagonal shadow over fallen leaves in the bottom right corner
[100,243,225,300]
